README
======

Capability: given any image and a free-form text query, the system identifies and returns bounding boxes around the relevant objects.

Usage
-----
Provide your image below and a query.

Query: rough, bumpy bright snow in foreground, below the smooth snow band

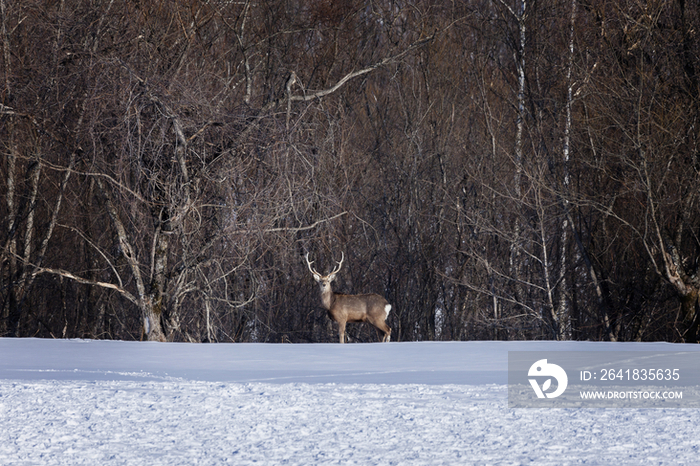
[0,381,700,465]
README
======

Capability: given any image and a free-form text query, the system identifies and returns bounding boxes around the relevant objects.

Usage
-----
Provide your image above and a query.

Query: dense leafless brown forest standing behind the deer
[0,0,700,343]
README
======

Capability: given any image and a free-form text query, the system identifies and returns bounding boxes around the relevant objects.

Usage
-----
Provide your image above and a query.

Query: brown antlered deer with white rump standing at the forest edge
[306,252,391,343]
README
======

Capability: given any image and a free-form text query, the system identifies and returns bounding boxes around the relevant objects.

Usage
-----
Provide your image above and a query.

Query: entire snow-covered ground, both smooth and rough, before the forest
[0,339,700,465]
